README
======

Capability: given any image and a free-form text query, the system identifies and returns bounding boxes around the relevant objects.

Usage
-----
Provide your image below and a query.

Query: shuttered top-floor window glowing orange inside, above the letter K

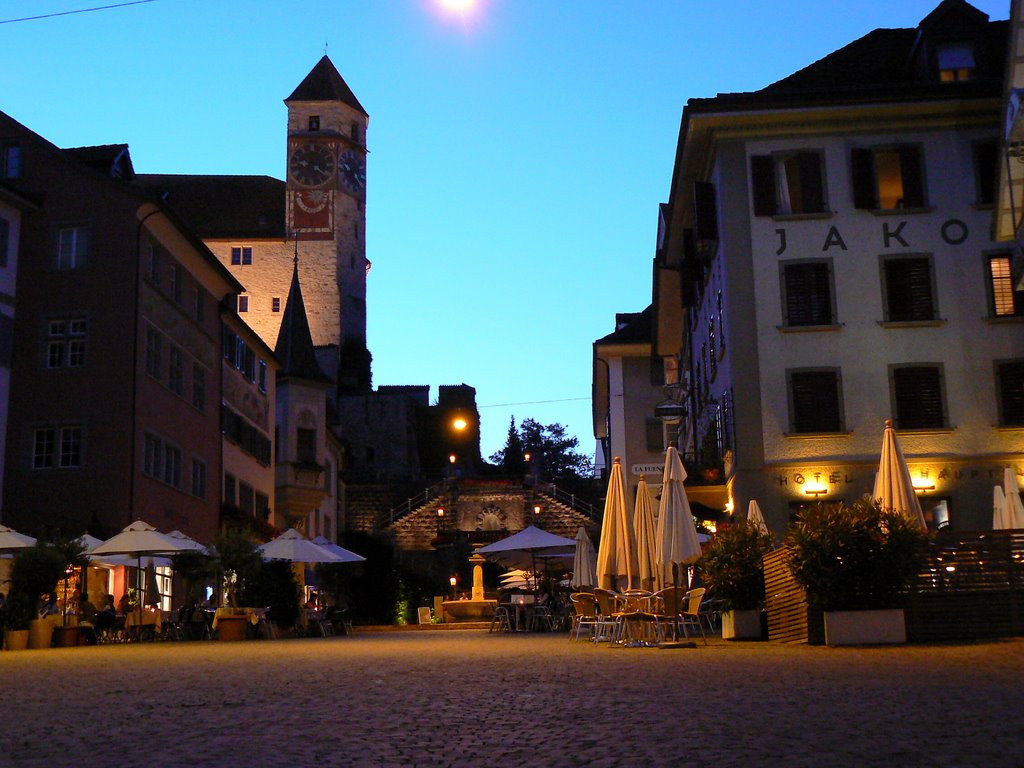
[850,144,927,211]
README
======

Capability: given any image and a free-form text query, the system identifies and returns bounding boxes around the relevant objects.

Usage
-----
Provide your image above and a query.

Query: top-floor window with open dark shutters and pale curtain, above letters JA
[751,152,825,216]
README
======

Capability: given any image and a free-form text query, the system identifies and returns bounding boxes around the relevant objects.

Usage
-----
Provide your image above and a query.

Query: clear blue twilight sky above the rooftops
[0,0,1010,456]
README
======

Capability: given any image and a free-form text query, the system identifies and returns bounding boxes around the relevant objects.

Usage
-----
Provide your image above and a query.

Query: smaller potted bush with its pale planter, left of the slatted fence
[700,520,773,640]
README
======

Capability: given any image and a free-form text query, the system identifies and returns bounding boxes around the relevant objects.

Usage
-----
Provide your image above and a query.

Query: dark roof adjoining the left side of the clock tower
[135,173,286,240]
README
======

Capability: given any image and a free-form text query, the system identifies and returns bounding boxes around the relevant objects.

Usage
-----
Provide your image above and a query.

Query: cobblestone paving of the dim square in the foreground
[0,631,1024,768]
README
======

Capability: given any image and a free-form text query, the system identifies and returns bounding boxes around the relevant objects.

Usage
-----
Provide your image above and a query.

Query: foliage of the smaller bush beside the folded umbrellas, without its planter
[700,520,772,610]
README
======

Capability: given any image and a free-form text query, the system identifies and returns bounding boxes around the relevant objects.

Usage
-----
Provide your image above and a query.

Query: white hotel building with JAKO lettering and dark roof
[655,0,1024,530]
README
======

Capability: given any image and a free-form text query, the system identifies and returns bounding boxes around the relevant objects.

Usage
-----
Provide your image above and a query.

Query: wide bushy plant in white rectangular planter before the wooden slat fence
[786,500,928,645]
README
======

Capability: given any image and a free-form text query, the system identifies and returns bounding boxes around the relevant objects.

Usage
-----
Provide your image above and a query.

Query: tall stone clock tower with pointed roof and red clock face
[285,55,371,394]
